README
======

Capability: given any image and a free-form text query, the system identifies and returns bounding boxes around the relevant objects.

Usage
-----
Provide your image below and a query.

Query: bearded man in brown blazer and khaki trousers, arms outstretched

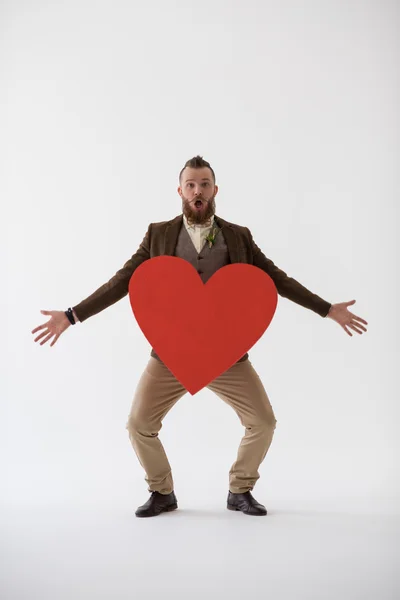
[32,156,367,517]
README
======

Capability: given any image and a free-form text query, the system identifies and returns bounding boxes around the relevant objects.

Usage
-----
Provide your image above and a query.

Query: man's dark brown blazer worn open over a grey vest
[72,214,331,321]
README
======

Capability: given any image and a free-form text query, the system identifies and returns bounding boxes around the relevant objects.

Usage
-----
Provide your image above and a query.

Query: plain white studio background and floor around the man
[0,0,400,600]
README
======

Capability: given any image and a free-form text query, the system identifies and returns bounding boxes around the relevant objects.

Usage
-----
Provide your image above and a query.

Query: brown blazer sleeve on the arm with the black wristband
[72,224,151,321]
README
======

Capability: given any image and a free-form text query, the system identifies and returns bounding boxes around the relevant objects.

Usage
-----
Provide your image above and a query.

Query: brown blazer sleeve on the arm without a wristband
[246,227,332,317]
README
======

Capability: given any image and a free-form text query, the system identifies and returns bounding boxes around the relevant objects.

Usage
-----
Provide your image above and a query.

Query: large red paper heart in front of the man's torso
[129,256,278,395]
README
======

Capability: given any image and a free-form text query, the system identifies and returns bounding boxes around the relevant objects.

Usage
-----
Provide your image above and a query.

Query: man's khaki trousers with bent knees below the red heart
[126,357,277,494]
